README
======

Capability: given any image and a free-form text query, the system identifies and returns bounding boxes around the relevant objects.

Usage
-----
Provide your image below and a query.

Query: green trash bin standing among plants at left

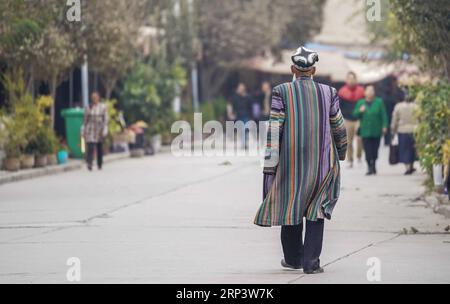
[61,108,84,159]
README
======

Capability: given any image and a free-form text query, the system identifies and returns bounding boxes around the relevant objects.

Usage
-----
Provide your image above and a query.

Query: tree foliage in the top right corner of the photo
[368,0,450,79]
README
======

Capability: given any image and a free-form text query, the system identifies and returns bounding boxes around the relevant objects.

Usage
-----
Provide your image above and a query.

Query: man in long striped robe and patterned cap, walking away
[255,47,347,274]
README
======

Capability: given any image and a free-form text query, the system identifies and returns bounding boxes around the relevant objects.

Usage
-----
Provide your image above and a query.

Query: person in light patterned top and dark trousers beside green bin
[82,92,108,171]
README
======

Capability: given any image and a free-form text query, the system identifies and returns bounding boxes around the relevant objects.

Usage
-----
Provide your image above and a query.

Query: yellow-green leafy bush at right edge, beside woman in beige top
[410,83,450,177]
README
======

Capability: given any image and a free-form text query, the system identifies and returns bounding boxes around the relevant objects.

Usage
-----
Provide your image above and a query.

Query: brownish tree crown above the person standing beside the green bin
[70,0,147,99]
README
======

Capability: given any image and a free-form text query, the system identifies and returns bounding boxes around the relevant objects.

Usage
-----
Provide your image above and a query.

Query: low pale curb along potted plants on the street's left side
[0,153,130,186]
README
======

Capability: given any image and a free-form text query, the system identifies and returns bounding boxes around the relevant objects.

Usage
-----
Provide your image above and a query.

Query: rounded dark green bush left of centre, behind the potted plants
[121,58,186,135]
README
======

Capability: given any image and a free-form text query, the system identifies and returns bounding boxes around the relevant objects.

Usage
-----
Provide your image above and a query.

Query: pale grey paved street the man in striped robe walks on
[0,151,450,284]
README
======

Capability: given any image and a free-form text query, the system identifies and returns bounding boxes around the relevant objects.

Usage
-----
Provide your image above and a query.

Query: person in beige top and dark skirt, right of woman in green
[391,90,419,175]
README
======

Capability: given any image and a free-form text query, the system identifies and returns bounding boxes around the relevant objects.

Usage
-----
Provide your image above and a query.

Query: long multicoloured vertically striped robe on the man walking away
[255,77,347,227]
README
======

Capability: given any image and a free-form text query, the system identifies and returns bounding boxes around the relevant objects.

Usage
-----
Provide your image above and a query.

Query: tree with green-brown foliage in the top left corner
[0,0,75,123]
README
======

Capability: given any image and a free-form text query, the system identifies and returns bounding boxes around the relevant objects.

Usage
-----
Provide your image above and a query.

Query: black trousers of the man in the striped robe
[281,220,325,270]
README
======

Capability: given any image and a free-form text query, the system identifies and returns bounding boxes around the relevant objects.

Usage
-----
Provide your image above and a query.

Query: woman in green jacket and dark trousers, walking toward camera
[353,85,389,175]
